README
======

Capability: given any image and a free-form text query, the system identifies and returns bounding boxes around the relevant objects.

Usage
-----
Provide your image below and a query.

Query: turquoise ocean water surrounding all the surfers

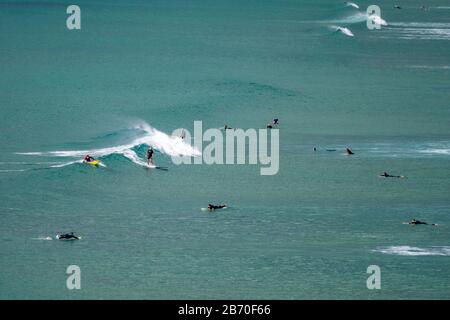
[0,0,450,299]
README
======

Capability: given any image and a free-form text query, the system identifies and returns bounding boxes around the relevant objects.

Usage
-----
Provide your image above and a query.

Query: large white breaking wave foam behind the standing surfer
[16,122,201,168]
